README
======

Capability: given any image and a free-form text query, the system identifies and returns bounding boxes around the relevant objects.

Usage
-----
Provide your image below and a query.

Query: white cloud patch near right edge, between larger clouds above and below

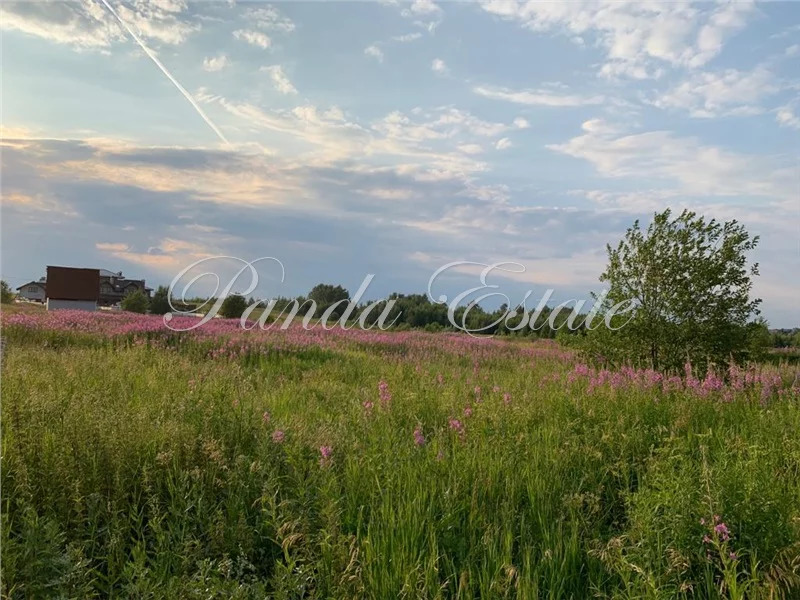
[652,67,780,118]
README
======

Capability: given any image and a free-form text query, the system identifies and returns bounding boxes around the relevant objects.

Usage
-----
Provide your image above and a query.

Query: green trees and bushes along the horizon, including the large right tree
[2,209,800,371]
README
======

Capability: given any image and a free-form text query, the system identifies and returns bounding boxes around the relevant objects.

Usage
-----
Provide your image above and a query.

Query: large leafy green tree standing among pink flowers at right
[585,209,763,370]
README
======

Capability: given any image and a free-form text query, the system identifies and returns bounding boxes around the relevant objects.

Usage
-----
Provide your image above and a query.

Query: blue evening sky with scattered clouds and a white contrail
[0,0,800,327]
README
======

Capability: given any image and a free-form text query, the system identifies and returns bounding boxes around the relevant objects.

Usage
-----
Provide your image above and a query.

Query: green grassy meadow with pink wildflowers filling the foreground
[0,311,800,600]
